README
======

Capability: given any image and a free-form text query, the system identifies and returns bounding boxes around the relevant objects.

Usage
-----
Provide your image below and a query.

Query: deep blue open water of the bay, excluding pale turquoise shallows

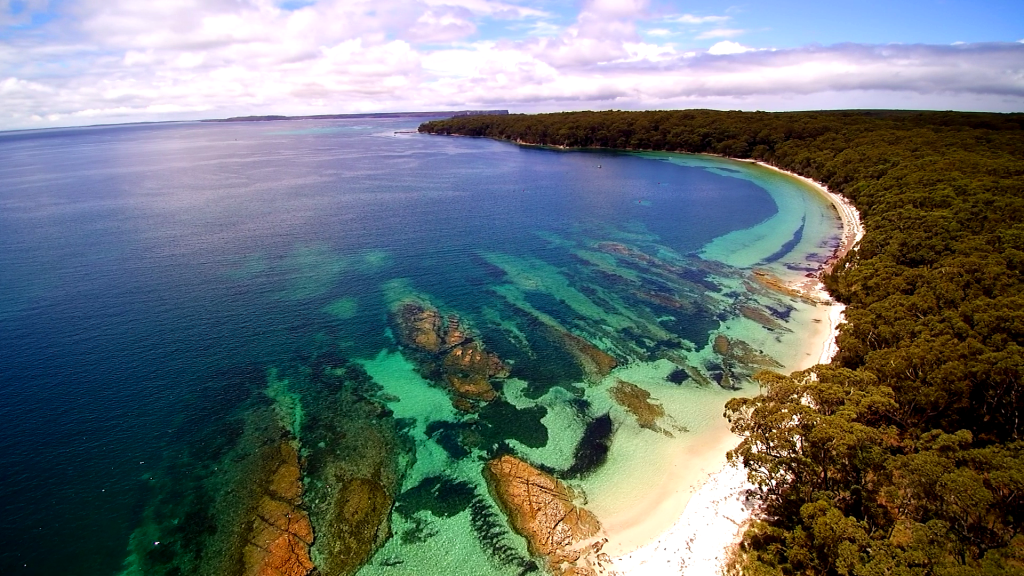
[0,120,831,575]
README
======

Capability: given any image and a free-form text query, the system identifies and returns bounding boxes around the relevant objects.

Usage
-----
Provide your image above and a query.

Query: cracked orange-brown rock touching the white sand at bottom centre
[483,455,601,574]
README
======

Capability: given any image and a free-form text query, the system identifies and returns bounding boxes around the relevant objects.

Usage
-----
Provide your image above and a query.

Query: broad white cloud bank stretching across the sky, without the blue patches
[0,0,1024,128]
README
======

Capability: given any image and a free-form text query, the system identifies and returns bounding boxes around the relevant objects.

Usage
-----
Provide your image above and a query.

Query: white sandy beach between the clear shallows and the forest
[602,160,864,576]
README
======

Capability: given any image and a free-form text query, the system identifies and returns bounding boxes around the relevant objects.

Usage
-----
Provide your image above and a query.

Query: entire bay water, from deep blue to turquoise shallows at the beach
[0,120,839,574]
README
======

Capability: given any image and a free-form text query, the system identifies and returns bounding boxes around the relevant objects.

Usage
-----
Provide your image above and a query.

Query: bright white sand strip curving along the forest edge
[592,162,864,576]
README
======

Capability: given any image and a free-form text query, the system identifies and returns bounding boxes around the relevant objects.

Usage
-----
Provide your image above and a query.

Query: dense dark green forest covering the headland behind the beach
[420,111,1024,576]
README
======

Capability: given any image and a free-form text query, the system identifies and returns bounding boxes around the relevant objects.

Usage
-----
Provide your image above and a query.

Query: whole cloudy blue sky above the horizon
[0,0,1024,130]
